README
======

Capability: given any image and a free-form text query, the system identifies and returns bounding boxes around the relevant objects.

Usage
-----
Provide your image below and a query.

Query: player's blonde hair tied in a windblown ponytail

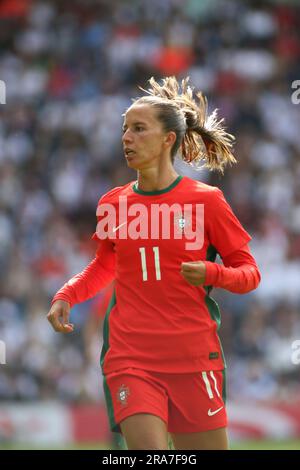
[134,77,236,173]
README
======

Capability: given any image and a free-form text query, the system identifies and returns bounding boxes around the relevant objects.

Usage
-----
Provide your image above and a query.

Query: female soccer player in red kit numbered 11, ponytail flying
[48,77,260,449]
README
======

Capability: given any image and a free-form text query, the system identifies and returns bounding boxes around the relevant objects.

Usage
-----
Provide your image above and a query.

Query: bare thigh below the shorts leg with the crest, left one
[120,413,168,450]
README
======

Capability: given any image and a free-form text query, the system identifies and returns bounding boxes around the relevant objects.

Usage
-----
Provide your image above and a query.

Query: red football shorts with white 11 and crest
[104,368,227,433]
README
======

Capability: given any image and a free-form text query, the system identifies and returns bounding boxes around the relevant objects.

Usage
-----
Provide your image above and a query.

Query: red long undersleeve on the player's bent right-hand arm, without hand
[204,245,260,294]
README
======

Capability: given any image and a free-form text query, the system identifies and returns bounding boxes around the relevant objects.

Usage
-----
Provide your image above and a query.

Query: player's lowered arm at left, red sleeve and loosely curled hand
[47,239,115,333]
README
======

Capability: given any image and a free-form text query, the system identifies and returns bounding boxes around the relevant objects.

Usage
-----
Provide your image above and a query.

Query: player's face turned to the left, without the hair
[122,104,170,170]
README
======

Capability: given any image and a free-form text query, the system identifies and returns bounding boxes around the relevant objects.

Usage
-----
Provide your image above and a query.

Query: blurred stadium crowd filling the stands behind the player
[0,0,300,402]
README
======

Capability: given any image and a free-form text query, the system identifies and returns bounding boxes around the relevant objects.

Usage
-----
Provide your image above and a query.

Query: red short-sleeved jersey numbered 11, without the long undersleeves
[95,177,251,374]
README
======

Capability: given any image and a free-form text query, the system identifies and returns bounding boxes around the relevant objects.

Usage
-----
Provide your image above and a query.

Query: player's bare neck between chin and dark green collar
[138,166,179,191]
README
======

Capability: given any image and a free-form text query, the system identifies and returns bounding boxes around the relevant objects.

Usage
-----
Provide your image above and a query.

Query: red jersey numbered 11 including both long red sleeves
[53,177,260,374]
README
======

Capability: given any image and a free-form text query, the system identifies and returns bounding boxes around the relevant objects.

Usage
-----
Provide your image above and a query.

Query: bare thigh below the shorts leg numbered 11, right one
[171,427,229,450]
